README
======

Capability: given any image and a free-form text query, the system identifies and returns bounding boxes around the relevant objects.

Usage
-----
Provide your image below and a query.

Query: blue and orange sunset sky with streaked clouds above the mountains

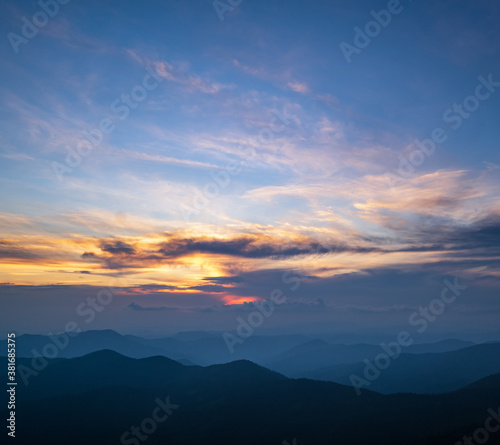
[0,0,500,339]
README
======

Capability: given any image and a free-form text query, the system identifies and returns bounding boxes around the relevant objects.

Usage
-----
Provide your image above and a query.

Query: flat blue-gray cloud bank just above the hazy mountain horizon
[0,274,500,340]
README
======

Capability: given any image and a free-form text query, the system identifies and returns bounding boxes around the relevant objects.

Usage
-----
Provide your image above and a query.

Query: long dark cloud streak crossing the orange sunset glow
[82,216,500,270]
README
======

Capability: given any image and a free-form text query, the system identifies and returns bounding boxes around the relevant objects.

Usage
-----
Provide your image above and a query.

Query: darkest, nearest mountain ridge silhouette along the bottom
[2,350,500,445]
